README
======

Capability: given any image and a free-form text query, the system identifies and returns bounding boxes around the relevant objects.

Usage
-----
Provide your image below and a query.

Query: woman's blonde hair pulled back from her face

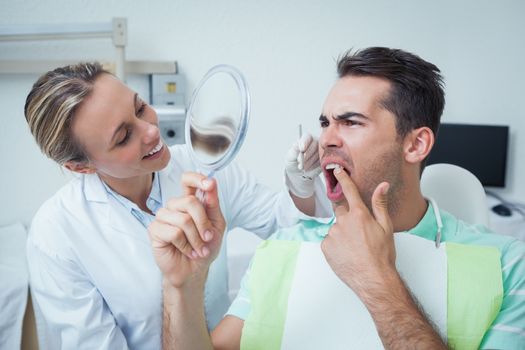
[24,62,110,165]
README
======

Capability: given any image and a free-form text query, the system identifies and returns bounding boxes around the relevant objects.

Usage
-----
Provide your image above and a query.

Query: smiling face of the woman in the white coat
[72,74,170,179]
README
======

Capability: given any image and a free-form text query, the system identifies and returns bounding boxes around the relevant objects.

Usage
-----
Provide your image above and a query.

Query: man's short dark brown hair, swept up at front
[337,47,445,137]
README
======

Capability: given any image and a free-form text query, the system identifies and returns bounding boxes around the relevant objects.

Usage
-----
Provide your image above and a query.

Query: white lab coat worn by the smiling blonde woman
[27,145,328,350]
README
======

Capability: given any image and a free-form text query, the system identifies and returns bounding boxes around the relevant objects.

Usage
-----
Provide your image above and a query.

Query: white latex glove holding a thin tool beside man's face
[284,134,321,198]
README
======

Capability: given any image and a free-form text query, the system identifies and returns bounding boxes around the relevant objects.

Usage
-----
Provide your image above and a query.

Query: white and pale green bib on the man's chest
[241,233,503,350]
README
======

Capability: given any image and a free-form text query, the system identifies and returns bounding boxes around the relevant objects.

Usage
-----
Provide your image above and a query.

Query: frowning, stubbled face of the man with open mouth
[319,76,403,208]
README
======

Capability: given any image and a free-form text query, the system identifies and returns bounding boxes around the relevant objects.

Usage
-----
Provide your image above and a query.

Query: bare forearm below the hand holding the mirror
[162,280,213,350]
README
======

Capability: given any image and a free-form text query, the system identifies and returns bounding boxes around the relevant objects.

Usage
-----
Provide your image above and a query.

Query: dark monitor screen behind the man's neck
[427,123,509,187]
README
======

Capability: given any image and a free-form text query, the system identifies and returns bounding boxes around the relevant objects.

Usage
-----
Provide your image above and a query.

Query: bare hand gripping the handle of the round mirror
[148,173,226,288]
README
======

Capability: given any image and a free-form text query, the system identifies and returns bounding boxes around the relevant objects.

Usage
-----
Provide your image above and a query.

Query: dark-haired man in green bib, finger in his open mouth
[150,47,525,349]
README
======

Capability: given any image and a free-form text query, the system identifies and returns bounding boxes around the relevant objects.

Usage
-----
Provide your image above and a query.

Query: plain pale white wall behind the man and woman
[0,0,525,225]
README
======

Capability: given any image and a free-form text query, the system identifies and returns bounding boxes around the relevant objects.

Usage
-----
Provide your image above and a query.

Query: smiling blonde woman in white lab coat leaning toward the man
[25,63,330,349]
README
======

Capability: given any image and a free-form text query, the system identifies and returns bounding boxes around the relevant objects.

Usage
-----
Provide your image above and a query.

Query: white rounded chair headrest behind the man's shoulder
[421,163,489,227]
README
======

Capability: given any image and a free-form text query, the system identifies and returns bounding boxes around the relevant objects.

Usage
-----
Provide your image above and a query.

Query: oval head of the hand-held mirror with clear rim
[185,65,250,177]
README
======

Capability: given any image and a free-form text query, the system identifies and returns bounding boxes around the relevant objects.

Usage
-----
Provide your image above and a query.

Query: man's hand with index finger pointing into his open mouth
[321,168,397,298]
